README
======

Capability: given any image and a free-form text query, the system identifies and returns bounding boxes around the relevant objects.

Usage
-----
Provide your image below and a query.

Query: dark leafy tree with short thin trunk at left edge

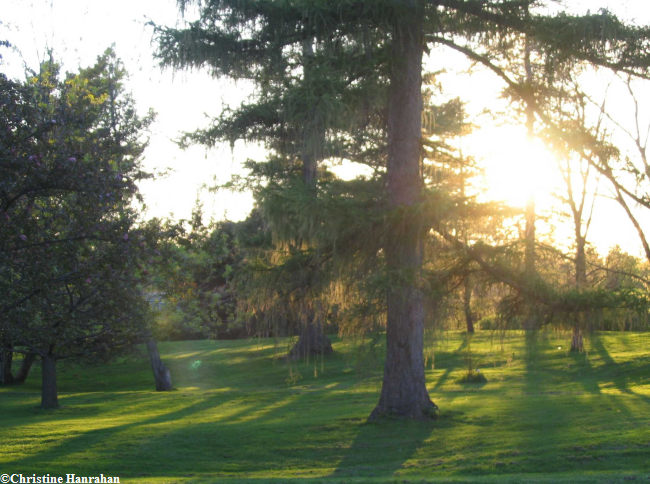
[0,49,151,408]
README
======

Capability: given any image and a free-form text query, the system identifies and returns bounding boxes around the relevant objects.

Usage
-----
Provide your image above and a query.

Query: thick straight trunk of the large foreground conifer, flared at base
[370,0,437,419]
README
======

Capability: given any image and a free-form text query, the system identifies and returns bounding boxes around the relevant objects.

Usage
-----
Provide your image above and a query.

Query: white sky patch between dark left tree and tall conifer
[0,0,259,220]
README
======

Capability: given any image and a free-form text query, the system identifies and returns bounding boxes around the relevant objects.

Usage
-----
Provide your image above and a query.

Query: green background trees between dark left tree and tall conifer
[149,205,270,340]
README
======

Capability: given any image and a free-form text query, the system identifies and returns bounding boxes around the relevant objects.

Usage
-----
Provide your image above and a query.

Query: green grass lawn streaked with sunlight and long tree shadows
[0,332,650,483]
